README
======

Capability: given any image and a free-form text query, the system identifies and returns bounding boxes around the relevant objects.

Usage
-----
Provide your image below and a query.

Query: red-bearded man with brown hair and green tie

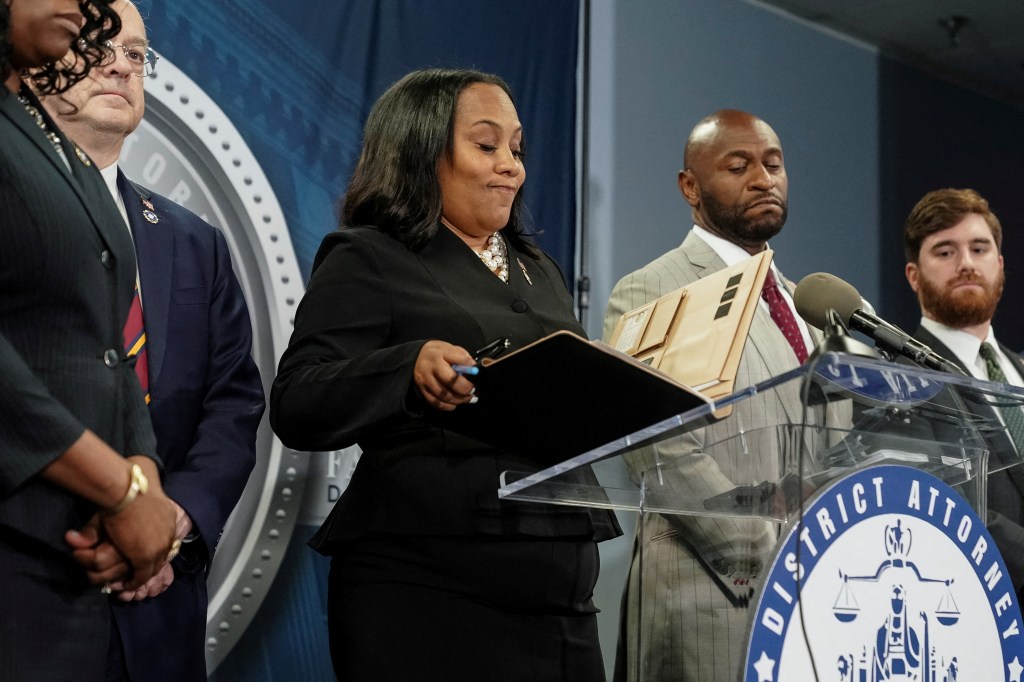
[903,189,1024,595]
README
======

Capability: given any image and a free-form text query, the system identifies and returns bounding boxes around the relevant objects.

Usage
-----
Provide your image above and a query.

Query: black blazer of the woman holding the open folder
[270,225,620,553]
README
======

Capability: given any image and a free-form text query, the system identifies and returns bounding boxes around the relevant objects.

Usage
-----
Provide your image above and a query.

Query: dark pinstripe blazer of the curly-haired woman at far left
[0,88,156,553]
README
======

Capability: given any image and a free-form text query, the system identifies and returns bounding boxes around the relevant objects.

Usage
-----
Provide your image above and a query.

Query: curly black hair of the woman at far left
[0,0,121,95]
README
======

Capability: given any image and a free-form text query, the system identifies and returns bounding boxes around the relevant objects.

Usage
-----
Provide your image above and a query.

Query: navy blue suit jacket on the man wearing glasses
[113,171,263,682]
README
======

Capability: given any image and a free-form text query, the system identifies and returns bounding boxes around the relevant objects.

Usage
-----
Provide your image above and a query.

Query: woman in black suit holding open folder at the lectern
[270,70,618,680]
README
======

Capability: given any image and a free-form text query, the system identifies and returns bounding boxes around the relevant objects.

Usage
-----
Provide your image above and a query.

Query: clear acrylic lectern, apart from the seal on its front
[499,353,1024,680]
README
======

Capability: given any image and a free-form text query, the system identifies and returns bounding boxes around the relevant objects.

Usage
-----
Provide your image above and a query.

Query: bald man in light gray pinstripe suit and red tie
[604,110,839,682]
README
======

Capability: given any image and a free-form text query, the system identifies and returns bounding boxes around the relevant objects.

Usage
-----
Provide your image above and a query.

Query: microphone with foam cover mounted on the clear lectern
[793,272,964,375]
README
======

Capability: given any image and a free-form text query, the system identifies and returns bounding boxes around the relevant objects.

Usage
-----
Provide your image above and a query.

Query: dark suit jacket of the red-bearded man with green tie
[913,327,1024,594]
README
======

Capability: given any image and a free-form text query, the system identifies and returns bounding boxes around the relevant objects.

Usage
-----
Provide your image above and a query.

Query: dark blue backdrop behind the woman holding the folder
[137,0,579,682]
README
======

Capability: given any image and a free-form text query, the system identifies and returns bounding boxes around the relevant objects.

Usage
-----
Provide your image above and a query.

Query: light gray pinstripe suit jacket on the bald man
[604,232,843,682]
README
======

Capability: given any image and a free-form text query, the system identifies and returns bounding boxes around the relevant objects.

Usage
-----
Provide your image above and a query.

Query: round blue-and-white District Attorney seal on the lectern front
[742,465,1024,682]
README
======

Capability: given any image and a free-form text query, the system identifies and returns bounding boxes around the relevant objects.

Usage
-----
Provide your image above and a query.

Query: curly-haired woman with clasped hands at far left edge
[0,0,175,682]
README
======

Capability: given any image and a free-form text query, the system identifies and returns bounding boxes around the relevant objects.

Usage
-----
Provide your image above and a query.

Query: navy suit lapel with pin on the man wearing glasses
[118,169,174,387]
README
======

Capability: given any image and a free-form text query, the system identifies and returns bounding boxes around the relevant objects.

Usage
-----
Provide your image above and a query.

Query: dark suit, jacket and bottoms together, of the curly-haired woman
[0,88,156,680]
